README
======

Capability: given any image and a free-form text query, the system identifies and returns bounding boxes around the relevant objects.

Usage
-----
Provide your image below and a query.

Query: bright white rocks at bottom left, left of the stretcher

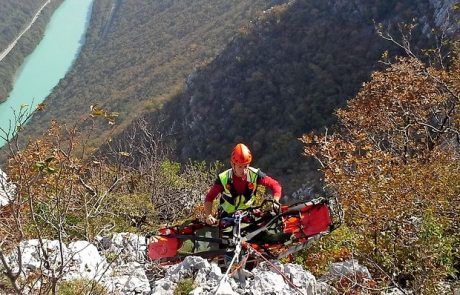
[8,233,151,294]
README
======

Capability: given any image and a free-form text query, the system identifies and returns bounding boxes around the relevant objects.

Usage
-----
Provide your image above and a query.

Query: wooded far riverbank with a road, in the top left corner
[0,0,63,102]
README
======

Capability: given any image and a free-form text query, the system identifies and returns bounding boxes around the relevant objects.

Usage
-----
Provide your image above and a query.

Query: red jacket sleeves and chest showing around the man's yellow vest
[204,171,281,202]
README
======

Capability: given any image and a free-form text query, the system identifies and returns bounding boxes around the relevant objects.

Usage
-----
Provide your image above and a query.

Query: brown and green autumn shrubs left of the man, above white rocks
[0,116,217,247]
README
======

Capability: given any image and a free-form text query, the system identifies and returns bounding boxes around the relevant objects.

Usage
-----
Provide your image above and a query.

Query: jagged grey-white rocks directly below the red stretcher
[152,256,333,295]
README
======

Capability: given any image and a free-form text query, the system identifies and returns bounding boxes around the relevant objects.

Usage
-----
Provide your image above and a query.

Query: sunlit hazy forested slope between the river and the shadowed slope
[22,0,283,146]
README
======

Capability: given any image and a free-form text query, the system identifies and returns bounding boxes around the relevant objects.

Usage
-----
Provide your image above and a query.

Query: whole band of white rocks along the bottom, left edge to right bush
[7,233,382,295]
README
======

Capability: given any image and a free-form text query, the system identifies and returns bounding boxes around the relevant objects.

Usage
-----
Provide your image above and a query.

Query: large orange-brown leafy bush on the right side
[302,53,460,293]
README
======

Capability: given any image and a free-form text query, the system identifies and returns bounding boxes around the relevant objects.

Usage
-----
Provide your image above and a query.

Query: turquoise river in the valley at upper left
[0,0,93,146]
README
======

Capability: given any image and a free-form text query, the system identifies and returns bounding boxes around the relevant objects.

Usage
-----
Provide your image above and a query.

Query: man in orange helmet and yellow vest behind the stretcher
[204,143,281,224]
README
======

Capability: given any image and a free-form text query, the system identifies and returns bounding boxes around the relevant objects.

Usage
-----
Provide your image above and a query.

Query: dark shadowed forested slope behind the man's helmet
[126,0,438,192]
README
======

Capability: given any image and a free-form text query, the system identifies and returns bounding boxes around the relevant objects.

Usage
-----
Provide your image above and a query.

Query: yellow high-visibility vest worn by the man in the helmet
[219,167,259,214]
